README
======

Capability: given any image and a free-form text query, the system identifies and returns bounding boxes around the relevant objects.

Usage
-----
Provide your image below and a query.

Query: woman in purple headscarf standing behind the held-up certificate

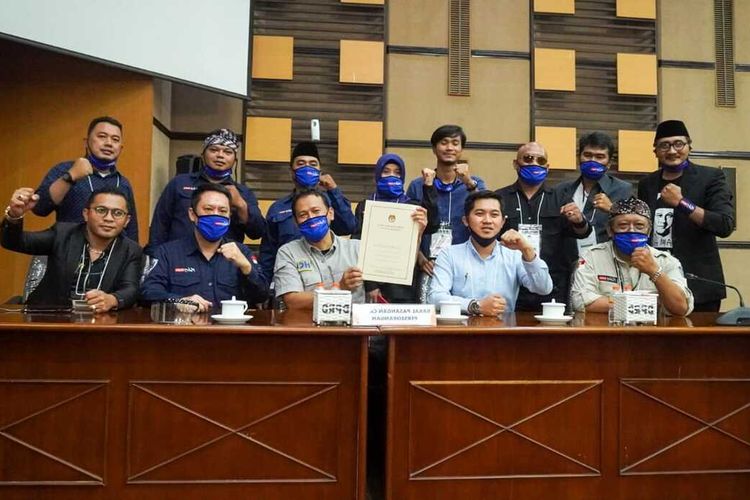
[352,153,440,304]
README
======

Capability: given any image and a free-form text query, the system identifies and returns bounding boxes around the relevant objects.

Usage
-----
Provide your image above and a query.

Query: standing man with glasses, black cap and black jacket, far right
[638,120,735,311]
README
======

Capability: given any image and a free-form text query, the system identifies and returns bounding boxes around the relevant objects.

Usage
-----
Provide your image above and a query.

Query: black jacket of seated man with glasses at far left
[0,219,141,309]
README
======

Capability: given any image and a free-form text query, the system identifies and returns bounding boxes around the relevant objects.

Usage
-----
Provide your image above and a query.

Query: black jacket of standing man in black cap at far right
[638,162,734,304]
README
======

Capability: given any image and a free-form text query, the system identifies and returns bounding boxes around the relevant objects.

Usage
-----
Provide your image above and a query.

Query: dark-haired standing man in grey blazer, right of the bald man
[555,132,633,261]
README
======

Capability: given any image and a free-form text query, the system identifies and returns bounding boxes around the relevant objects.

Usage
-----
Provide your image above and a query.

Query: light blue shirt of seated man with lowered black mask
[427,239,552,312]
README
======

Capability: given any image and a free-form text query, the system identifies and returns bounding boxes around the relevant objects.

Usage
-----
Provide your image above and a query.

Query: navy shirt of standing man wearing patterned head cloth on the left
[144,172,266,255]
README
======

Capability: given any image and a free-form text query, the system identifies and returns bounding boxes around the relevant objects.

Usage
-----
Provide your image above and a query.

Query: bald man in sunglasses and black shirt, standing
[496,142,591,311]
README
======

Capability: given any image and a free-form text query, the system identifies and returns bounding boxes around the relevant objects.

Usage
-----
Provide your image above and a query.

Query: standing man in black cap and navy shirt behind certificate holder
[260,142,357,279]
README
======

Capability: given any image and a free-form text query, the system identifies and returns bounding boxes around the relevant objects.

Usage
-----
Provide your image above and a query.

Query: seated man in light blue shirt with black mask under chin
[428,191,552,316]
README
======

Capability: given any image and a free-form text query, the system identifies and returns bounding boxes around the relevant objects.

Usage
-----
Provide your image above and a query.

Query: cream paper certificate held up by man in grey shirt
[357,200,419,285]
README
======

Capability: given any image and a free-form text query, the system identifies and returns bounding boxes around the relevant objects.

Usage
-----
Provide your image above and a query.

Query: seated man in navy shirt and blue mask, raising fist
[141,183,268,312]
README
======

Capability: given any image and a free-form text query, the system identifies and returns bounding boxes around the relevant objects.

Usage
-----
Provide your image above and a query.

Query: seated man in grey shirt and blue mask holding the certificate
[273,189,427,309]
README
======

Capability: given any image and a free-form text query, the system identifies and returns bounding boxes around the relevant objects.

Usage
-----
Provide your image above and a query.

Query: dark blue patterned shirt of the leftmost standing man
[32,161,138,243]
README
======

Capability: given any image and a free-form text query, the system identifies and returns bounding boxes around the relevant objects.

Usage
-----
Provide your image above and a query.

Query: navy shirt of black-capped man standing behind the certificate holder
[260,188,357,280]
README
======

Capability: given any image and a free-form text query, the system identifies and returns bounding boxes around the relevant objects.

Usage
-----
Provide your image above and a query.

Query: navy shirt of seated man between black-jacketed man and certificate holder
[141,234,268,307]
